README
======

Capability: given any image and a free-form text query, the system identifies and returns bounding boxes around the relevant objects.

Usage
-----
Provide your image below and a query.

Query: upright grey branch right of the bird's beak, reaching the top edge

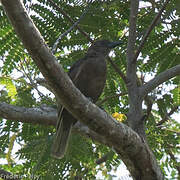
[126,0,146,139]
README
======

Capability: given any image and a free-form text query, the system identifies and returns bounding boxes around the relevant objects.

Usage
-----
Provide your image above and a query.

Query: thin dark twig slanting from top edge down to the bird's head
[49,0,93,42]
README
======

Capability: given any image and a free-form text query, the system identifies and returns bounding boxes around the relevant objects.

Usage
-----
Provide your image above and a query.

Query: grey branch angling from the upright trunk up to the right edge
[140,65,180,97]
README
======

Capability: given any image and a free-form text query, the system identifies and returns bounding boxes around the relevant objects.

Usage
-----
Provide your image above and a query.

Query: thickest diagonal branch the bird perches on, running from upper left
[1,0,163,180]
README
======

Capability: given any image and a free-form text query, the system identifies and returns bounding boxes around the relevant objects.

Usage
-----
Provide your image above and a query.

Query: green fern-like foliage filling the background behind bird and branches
[0,0,180,180]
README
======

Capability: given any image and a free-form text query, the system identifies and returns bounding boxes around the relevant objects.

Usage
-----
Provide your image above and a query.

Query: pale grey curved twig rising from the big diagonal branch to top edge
[52,0,92,54]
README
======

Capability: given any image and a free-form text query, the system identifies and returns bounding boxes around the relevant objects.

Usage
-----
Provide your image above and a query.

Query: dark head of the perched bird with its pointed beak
[87,40,122,56]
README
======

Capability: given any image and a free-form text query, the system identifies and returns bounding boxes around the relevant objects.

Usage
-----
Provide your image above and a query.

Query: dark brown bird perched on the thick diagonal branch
[51,40,121,159]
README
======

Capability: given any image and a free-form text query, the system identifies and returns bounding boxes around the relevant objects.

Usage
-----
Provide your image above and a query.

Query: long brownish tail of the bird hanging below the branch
[51,116,73,159]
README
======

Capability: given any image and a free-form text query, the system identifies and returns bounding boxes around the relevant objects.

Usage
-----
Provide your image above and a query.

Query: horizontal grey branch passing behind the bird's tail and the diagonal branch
[0,103,110,146]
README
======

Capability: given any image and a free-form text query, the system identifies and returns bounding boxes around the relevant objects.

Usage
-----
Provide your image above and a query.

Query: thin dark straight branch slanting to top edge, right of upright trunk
[133,0,170,62]
